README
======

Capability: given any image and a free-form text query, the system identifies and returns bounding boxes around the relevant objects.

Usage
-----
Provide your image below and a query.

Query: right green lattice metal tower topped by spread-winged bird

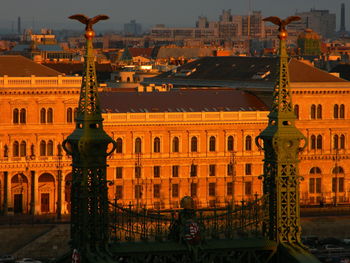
[256,17,306,247]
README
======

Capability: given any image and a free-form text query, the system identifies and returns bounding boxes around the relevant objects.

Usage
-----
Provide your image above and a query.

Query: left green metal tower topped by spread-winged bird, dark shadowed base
[62,15,116,262]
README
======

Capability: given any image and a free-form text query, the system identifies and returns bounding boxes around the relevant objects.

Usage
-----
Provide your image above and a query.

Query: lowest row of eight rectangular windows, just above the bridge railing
[115,181,252,200]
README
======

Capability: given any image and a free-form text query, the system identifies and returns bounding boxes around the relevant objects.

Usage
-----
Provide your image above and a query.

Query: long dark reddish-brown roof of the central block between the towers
[99,89,268,113]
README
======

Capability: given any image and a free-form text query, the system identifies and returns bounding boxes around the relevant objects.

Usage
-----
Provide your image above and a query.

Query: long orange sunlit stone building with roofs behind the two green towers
[0,56,350,214]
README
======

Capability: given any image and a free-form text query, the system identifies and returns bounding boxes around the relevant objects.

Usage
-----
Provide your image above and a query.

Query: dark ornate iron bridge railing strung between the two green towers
[109,196,266,242]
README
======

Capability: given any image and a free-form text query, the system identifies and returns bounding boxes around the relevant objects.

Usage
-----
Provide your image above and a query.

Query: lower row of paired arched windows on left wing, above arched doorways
[9,140,54,157]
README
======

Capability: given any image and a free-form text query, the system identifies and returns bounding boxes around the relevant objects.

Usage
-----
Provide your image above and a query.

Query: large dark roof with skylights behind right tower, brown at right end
[148,56,346,83]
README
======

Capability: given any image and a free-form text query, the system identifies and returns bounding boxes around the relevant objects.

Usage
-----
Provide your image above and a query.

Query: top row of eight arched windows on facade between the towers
[116,135,252,153]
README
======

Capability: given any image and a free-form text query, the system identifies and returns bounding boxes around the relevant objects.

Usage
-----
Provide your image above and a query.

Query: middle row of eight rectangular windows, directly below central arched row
[115,163,253,179]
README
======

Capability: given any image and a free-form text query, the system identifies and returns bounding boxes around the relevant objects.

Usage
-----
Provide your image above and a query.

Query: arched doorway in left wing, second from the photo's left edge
[38,173,56,214]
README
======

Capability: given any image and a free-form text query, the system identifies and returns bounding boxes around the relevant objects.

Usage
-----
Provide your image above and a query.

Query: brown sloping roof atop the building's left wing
[0,55,62,77]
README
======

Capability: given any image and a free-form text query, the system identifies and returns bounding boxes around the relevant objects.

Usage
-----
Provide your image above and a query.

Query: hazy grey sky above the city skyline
[0,0,350,30]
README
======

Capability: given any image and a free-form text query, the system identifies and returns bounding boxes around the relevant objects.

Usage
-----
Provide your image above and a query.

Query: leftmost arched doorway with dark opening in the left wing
[11,173,29,214]
